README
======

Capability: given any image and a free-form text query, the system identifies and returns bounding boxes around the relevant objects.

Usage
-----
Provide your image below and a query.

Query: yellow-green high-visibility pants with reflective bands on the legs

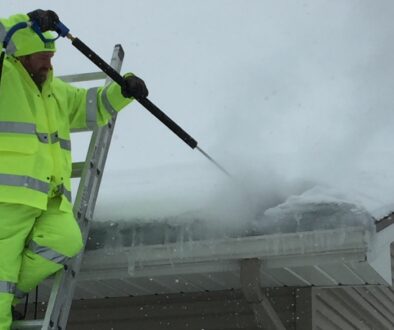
[0,197,83,330]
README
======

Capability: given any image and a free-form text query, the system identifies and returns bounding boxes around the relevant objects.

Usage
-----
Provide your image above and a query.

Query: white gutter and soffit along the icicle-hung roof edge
[79,226,394,286]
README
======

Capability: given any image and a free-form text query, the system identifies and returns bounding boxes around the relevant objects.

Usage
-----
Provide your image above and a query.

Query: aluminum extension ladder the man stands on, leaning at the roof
[12,45,124,330]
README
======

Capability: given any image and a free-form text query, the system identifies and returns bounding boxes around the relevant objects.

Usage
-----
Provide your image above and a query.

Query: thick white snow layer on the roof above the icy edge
[87,163,375,235]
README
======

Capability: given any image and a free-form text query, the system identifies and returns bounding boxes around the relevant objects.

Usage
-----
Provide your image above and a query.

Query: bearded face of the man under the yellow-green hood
[19,52,54,88]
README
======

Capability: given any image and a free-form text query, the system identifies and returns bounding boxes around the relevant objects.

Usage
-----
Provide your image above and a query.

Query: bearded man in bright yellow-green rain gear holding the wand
[0,10,148,330]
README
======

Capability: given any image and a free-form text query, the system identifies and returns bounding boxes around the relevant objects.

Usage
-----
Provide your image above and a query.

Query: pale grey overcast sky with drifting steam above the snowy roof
[0,0,394,223]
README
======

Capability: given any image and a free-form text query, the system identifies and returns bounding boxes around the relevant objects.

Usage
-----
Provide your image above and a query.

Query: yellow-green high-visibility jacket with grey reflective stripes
[0,51,131,212]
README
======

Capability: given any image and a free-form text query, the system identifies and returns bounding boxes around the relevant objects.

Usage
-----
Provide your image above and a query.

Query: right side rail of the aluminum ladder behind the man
[42,45,123,330]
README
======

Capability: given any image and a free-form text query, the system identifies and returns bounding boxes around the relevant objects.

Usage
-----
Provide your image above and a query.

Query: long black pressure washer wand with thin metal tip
[66,33,231,177]
